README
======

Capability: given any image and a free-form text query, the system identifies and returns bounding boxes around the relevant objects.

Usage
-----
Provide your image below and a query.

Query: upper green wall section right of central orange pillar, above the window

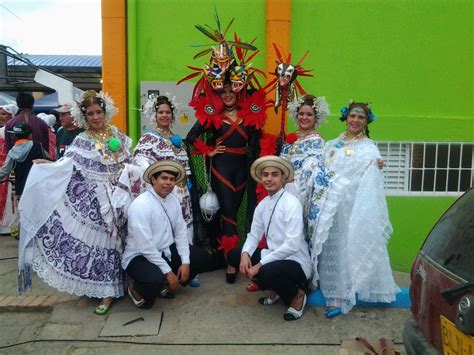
[291,0,474,141]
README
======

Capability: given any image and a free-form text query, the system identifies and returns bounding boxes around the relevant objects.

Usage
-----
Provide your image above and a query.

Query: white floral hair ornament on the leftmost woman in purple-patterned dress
[71,90,118,129]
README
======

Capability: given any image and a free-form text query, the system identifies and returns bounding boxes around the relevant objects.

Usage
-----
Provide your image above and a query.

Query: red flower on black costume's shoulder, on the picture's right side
[237,89,272,129]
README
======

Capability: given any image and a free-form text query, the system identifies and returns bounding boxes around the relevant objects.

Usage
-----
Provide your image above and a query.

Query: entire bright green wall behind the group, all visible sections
[127,0,474,271]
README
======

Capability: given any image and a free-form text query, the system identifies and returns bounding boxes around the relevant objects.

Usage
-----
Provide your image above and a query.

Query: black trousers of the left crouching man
[126,244,210,307]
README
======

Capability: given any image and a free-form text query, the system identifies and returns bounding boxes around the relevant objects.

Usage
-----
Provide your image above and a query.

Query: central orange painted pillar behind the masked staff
[264,0,291,134]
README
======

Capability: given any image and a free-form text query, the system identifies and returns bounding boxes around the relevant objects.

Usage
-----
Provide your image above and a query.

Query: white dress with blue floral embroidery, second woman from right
[280,132,349,288]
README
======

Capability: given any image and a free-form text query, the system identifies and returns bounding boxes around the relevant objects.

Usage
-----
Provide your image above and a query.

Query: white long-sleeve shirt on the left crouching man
[122,189,189,274]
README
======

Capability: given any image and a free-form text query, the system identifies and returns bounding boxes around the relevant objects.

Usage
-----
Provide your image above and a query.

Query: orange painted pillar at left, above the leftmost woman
[102,0,127,132]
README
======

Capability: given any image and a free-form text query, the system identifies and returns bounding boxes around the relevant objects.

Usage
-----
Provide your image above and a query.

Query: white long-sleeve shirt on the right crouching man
[242,189,311,278]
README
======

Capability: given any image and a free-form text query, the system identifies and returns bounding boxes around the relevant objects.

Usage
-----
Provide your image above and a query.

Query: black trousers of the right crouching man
[227,248,308,306]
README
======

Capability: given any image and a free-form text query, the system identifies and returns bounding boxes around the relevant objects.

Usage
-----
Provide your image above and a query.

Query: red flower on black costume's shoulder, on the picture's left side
[189,92,224,129]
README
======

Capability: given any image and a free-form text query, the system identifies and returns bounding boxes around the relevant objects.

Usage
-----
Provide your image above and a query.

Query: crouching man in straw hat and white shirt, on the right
[227,155,311,321]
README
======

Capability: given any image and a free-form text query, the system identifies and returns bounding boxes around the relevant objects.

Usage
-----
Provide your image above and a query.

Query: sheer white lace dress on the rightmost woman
[318,135,400,313]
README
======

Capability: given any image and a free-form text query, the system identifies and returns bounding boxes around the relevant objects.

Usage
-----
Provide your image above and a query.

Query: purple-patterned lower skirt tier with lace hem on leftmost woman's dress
[28,211,123,298]
